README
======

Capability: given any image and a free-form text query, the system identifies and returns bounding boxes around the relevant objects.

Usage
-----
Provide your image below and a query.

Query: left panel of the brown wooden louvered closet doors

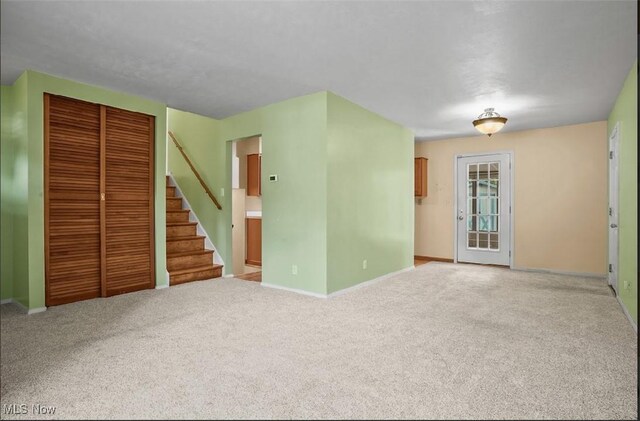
[44,94,101,306]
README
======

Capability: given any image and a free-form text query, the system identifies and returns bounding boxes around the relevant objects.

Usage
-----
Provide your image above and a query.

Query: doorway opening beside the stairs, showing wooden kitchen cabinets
[231,135,262,282]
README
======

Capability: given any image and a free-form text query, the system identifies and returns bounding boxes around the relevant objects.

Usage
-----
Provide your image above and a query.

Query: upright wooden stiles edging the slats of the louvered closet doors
[43,92,156,306]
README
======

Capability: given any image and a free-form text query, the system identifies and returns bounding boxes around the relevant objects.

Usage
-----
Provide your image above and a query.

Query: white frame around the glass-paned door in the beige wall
[452,150,515,269]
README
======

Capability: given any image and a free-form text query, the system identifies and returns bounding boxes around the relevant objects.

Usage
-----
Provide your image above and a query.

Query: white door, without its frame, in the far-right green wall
[608,124,619,294]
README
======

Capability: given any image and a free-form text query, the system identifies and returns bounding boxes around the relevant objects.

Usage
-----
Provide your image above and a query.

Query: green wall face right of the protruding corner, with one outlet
[326,93,414,293]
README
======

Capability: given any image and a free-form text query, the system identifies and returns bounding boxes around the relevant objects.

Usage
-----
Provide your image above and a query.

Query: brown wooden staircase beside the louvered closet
[167,176,222,285]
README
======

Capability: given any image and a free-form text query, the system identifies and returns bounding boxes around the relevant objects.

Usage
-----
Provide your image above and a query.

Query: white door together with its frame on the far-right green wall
[607,122,620,295]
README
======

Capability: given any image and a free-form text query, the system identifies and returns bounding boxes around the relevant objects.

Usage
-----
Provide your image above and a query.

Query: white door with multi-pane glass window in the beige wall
[455,153,511,266]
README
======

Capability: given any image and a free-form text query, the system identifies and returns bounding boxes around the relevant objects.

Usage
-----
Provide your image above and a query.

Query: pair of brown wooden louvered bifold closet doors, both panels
[44,94,155,306]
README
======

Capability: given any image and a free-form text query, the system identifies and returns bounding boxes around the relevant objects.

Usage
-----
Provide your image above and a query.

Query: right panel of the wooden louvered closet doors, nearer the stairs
[105,107,155,296]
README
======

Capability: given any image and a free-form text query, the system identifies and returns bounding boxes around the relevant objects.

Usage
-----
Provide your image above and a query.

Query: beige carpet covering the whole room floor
[0,263,638,419]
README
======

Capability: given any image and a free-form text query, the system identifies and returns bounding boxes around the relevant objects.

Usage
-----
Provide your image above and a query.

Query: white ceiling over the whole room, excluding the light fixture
[0,0,637,140]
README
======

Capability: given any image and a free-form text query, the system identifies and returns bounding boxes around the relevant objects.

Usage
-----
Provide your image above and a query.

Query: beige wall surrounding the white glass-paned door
[415,121,608,275]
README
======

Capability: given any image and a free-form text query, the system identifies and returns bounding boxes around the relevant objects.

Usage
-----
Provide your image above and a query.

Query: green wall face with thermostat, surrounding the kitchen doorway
[220,92,327,294]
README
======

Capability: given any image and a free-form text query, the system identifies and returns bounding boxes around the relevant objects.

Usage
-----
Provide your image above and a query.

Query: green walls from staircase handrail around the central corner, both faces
[168,92,414,294]
